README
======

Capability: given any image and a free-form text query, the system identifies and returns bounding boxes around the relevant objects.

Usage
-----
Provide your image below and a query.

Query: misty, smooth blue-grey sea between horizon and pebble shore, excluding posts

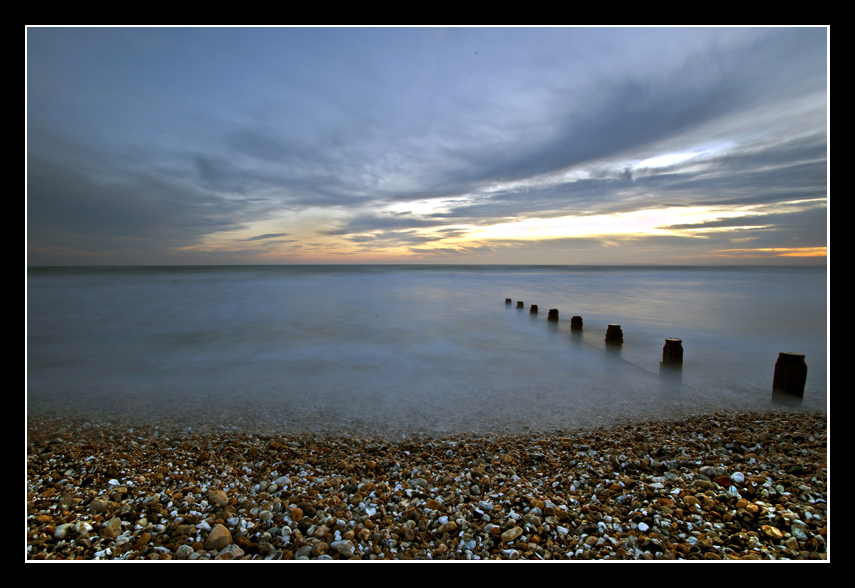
[27,266,828,434]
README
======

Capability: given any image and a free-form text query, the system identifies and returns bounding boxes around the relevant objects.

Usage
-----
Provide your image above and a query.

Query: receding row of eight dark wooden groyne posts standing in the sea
[505,298,807,404]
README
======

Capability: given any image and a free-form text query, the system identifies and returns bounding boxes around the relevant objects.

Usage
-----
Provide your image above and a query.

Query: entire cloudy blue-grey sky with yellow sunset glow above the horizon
[26,27,829,266]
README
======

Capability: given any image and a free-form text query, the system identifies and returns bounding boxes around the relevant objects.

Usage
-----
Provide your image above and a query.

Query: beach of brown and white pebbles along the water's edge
[26,409,828,561]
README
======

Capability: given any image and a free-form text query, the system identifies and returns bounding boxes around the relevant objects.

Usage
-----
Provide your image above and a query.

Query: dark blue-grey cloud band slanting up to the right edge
[378,29,825,197]
